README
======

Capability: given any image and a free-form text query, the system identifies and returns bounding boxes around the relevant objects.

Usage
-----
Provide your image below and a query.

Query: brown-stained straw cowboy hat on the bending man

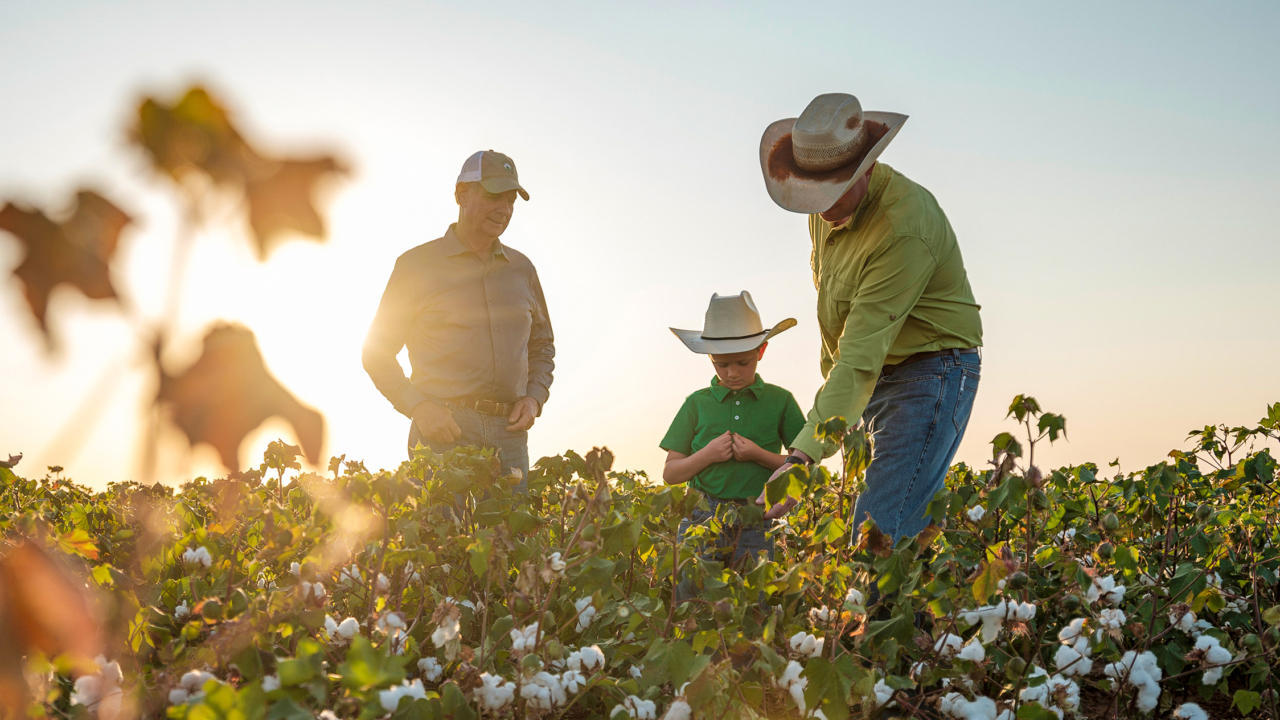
[760,92,906,213]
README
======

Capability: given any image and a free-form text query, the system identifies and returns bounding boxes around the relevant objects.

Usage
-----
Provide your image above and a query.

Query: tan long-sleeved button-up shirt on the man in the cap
[364,225,556,416]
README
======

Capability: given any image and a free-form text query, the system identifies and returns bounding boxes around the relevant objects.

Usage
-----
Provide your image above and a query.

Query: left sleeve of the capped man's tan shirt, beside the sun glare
[362,258,428,418]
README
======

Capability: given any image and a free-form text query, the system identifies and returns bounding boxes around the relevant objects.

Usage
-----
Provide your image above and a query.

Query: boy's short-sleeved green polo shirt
[662,374,804,500]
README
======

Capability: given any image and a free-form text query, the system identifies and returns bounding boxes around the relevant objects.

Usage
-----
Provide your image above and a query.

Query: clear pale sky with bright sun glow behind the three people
[0,0,1280,486]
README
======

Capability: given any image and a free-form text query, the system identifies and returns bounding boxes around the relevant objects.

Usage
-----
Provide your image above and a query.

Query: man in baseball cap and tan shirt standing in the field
[364,150,556,486]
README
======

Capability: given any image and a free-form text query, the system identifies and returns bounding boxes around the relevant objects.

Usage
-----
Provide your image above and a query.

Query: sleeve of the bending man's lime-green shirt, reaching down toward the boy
[791,237,937,460]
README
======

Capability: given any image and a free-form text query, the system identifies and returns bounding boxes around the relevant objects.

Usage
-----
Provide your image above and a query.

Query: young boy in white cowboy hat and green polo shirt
[662,291,805,601]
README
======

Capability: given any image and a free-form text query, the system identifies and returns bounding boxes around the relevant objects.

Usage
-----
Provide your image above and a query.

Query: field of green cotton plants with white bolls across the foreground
[0,397,1280,720]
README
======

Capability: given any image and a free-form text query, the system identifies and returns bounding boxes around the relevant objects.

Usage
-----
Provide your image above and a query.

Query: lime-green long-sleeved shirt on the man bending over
[791,163,982,459]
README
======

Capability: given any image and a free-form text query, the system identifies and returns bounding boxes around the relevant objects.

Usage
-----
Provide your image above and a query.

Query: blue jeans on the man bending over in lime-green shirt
[854,354,982,542]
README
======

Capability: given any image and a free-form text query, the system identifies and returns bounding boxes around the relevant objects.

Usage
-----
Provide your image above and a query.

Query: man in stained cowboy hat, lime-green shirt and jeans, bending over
[758,94,982,539]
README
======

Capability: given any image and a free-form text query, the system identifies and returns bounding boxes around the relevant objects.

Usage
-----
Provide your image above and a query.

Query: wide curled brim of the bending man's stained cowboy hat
[760,110,906,214]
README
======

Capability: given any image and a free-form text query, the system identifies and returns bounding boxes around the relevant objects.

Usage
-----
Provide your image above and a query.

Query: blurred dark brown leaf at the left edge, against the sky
[0,190,132,347]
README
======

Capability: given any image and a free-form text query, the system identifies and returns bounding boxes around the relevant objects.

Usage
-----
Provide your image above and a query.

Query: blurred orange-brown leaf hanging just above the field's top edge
[157,323,324,470]
